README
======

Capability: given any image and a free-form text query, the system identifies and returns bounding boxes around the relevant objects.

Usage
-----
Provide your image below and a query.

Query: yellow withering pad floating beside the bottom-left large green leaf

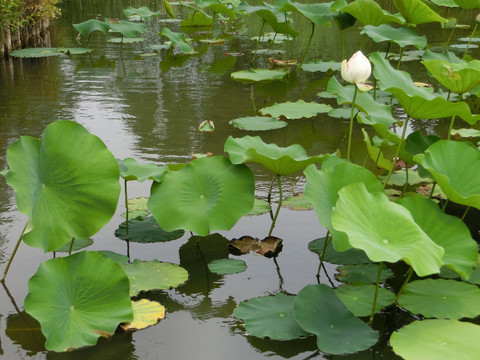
[120,299,165,331]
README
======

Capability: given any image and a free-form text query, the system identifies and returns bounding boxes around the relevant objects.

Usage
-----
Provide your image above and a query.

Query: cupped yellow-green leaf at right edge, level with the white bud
[422,60,480,94]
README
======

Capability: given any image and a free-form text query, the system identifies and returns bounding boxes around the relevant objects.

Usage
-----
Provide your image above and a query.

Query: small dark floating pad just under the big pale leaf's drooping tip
[335,264,393,282]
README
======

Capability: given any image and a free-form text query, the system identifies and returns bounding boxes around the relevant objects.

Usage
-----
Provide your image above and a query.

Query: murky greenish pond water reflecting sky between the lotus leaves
[0,0,478,360]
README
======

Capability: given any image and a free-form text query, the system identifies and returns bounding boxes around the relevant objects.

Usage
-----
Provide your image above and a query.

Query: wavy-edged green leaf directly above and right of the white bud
[360,24,427,50]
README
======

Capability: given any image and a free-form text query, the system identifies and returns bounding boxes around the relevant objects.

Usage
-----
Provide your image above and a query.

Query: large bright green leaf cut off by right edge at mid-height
[412,140,480,209]
